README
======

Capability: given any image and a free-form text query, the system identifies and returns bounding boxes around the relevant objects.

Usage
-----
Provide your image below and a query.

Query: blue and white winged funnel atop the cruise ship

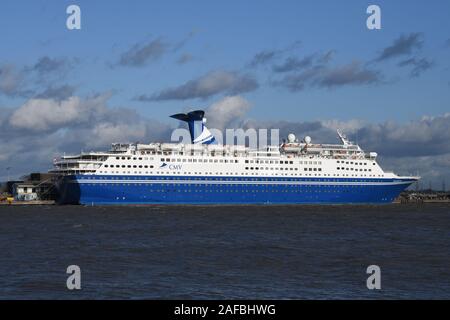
[170,110,217,144]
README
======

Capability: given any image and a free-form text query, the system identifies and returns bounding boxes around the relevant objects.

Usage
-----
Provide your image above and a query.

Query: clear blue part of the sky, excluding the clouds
[0,1,450,121]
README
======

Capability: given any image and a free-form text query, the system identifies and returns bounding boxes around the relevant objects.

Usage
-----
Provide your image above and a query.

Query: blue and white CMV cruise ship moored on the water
[50,110,419,205]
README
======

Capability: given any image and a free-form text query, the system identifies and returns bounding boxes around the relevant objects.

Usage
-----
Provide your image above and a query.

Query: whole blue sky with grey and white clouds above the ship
[0,0,450,188]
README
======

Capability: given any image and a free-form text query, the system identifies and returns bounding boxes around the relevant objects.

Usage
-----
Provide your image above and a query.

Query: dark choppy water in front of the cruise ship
[0,204,450,299]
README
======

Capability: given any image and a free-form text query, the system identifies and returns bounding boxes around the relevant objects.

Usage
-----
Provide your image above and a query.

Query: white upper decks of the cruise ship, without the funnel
[51,130,384,177]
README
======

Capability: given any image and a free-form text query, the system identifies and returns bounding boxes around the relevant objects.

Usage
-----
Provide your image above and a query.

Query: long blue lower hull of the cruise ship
[58,175,416,205]
